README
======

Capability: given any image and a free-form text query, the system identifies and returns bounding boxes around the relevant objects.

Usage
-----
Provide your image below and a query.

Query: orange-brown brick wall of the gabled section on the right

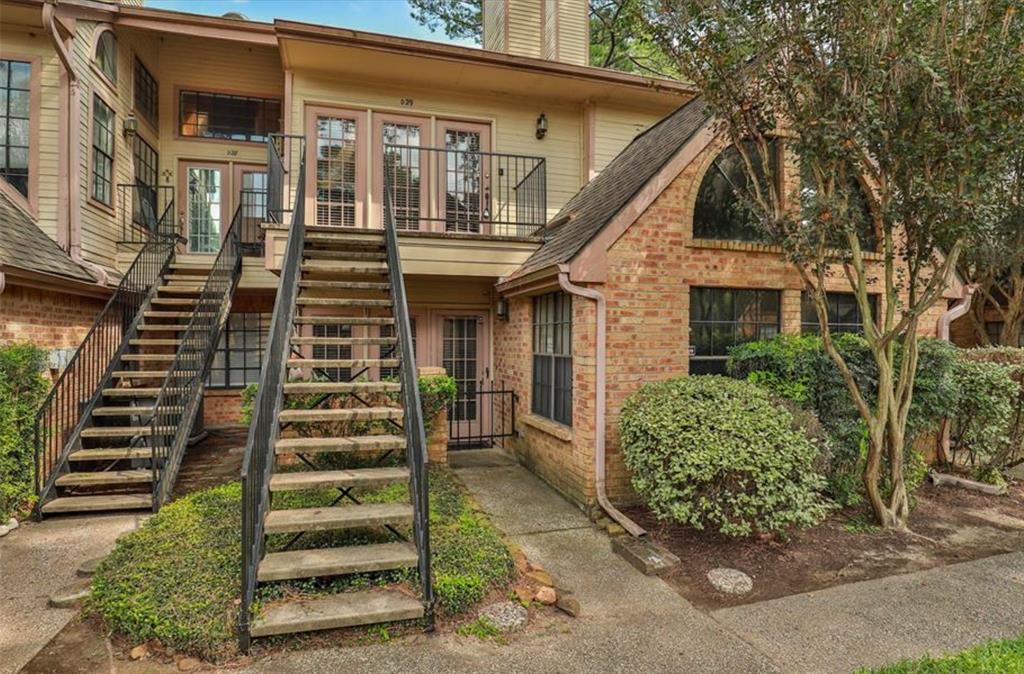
[495,132,958,506]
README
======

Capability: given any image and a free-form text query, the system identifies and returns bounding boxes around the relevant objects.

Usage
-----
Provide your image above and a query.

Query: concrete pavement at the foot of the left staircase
[0,514,138,674]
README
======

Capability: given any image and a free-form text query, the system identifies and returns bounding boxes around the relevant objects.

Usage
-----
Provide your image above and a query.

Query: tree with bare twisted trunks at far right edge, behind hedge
[961,152,1024,346]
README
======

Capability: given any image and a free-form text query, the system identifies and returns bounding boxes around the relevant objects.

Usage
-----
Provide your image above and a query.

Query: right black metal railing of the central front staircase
[384,177,434,630]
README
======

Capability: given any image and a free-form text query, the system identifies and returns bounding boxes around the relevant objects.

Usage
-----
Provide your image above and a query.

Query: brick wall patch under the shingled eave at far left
[0,285,105,349]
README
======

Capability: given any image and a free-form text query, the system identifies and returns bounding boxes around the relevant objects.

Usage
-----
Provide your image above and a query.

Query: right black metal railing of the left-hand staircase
[148,206,243,503]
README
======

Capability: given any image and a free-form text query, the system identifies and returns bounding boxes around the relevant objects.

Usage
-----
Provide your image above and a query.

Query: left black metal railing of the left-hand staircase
[34,196,180,516]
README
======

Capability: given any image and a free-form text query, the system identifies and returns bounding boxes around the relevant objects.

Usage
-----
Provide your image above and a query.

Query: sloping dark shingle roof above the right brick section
[510,96,710,278]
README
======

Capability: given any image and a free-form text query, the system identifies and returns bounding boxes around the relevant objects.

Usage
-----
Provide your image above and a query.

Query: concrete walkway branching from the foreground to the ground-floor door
[243,455,1024,674]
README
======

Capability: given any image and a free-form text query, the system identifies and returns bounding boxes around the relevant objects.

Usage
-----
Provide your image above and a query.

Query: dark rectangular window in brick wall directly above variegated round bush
[690,288,781,375]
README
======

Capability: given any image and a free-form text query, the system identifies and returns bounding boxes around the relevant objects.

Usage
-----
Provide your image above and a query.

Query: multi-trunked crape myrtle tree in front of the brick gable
[647,0,1024,529]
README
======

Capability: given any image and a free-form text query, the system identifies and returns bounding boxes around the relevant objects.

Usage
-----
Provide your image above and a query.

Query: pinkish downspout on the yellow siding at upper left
[42,2,109,286]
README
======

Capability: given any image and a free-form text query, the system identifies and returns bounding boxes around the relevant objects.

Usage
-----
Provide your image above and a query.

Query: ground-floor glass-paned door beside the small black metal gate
[441,314,489,446]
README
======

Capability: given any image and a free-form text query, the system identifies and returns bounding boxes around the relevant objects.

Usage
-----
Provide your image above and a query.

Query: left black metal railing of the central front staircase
[239,136,306,651]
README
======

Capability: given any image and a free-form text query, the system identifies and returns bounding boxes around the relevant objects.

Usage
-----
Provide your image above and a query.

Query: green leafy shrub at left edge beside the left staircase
[0,344,49,522]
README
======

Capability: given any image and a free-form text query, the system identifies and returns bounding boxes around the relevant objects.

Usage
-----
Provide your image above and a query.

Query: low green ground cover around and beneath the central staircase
[88,468,515,661]
